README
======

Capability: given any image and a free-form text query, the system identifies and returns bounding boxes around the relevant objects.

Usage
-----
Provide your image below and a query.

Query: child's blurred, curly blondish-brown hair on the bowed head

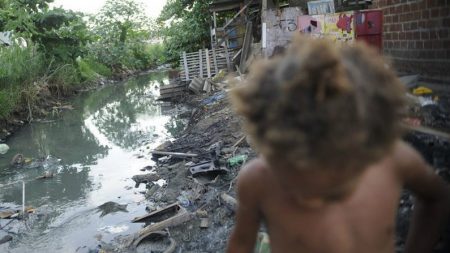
[231,36,405,172]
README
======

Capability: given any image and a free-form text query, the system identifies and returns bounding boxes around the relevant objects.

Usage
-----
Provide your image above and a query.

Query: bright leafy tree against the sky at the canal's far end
[90,0,158,72]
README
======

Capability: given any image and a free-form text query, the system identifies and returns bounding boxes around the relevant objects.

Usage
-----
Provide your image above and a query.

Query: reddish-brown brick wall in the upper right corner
[372,0,450,84]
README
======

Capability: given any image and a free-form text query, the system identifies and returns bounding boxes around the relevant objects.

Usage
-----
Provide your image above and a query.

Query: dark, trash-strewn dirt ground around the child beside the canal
[118,87,450,253]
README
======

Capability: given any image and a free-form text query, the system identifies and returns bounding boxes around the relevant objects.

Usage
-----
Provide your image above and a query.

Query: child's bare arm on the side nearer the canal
[227,162,261,253]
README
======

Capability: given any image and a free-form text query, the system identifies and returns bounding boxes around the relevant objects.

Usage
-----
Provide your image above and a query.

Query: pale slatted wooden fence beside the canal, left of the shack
[180,49,233,81]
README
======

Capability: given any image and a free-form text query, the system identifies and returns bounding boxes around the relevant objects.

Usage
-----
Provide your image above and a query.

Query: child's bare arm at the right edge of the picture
[398,141,450,253]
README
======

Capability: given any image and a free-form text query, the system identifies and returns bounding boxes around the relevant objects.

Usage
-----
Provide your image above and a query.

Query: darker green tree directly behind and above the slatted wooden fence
[157,0,212,63]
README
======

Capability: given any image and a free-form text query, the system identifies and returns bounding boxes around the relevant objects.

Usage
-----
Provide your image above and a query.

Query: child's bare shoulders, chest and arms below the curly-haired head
[227,141,450,253]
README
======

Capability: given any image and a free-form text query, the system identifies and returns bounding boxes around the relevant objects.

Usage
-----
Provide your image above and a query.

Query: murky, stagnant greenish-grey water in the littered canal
[0,72,185,253]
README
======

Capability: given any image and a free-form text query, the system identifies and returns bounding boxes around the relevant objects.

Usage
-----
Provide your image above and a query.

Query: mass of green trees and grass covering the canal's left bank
[0,0,166,120]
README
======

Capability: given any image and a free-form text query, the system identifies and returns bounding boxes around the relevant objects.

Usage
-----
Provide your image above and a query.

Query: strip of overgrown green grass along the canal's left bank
[0,43,165,120]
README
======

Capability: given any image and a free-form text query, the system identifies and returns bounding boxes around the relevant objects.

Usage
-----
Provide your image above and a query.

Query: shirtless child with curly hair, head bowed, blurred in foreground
[227,38,450,253]
